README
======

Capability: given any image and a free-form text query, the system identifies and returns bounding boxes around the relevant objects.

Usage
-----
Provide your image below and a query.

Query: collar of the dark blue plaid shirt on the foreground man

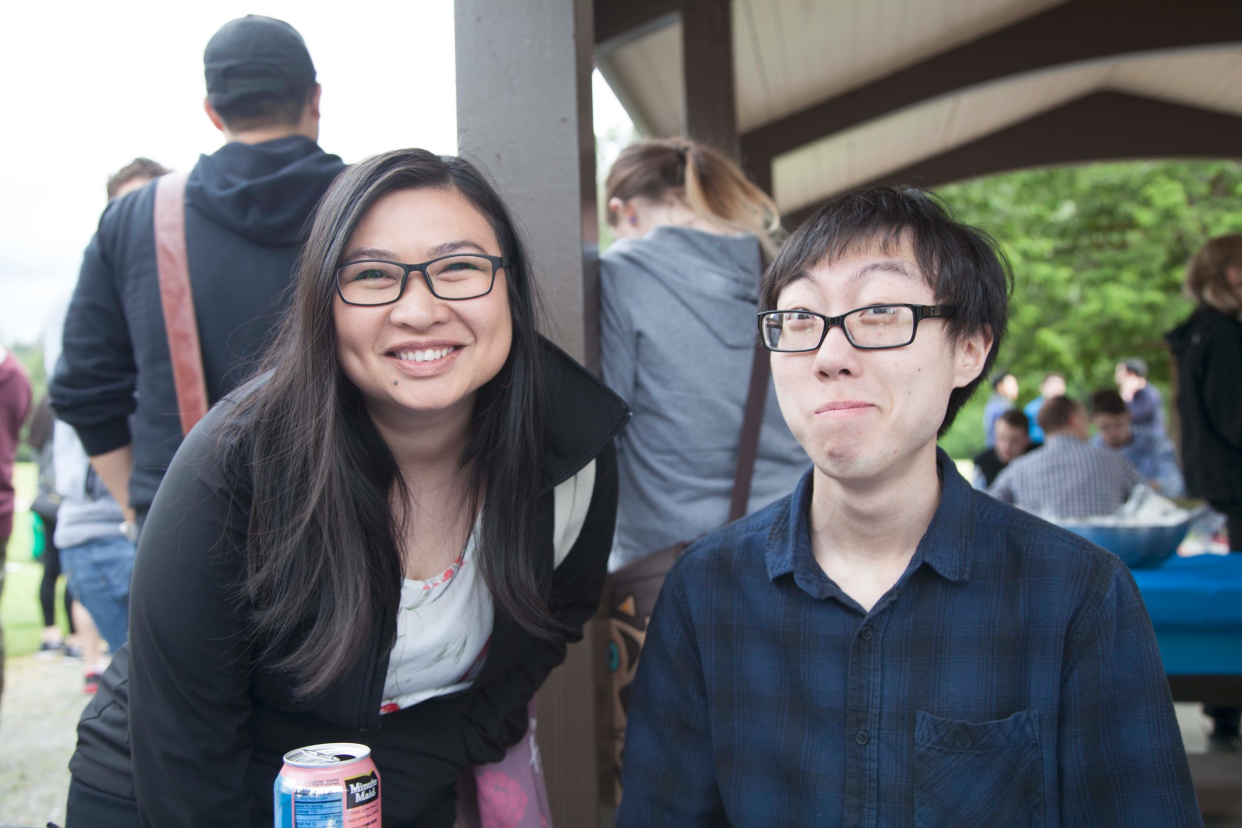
[766,448,975,598]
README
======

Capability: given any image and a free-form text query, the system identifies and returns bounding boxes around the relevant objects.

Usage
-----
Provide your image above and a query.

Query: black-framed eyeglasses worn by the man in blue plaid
[759,304,954,354]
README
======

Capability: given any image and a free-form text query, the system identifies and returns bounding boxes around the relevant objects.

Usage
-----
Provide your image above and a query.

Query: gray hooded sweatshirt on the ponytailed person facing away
[600,227,810,569]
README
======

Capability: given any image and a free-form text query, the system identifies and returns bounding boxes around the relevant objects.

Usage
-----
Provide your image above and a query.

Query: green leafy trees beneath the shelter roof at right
[939,161,1242,457]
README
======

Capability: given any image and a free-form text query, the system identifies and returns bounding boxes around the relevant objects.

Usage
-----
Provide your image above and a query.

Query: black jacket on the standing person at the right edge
[1165,308,1242,506]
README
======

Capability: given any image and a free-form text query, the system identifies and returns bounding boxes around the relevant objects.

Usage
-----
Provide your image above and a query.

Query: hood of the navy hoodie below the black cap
[185,135,345,247]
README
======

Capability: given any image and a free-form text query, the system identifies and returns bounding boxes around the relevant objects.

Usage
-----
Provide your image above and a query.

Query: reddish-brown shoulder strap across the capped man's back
[155,173,207,434]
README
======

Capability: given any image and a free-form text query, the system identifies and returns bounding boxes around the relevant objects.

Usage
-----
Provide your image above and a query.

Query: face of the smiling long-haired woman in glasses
[333,187,514,422]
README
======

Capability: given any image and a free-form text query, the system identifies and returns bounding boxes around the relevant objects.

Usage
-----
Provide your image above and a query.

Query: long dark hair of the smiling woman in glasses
[224,149,555,698]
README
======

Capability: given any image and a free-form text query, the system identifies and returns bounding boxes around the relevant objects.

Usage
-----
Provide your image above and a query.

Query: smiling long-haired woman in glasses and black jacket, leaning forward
[67,150,628,828]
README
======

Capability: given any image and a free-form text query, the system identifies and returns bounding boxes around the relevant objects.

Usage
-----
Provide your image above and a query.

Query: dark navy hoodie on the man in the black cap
[50,135,344,508]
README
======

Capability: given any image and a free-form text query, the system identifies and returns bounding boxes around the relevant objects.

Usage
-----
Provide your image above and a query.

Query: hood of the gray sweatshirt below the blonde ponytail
[601,226,763,348]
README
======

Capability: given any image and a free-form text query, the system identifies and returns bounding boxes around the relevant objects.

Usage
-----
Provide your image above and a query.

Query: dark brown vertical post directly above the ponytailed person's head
[681,0,740,159]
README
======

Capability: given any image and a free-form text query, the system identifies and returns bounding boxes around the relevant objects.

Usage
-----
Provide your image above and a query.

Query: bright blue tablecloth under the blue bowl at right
[1134,555,1242,675]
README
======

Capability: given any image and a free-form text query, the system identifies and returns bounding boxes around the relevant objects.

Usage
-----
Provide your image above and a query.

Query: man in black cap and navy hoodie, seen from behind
[50,15,344,538]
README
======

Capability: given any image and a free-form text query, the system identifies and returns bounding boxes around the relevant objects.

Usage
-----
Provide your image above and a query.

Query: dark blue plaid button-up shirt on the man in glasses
[617,453,1201,828]
